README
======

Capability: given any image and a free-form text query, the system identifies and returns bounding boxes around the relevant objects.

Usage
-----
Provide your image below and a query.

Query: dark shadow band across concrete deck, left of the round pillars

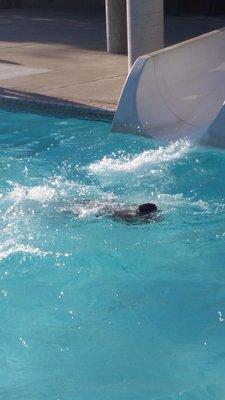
[0,9,106,51]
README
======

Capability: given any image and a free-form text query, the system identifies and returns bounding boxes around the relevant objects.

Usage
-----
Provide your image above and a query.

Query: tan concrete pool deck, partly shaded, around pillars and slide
[0,9,225,117]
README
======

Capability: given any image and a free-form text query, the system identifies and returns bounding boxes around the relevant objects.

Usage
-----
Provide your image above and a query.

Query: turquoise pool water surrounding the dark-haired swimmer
[0,111,225,400]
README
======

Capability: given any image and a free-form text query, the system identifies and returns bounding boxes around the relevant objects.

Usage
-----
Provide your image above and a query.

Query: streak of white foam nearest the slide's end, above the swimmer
[88,140,191,174]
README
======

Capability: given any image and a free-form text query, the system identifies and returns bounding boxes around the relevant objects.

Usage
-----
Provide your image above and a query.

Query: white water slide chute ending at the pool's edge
[112,29,225,142]
